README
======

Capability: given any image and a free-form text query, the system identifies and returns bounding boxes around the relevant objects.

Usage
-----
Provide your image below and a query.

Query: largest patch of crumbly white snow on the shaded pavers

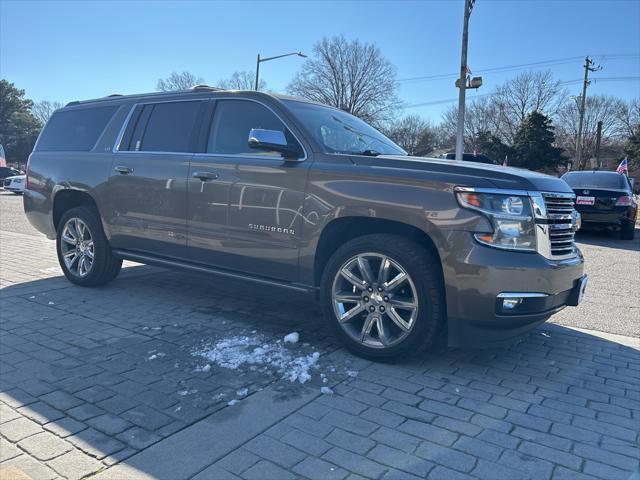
[193,336,320,383]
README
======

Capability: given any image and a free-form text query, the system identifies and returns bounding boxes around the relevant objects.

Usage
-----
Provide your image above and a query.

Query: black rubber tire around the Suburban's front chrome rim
[320,234,446,360]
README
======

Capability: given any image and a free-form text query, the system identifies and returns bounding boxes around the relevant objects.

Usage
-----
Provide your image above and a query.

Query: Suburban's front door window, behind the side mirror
[207,100,300,157]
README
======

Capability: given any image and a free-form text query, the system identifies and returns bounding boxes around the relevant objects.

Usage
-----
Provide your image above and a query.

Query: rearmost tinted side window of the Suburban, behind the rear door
[38,106,118,151]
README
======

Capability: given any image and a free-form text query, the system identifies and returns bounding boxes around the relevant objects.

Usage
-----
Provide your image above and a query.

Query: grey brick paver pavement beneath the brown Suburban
[0,219,640,480]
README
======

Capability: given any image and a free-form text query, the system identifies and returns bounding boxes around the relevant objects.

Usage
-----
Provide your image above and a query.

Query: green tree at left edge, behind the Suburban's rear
[0,80,42,165]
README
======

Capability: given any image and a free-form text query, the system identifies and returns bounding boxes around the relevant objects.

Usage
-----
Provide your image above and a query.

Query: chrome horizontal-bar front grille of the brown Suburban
[542,193,576,258]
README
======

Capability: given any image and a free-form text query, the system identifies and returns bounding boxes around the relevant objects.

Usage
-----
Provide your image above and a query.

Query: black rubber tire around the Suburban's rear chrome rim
[56,207,122,287]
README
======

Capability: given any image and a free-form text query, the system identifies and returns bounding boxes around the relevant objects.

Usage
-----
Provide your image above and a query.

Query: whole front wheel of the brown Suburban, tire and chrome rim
[321,234,445,359]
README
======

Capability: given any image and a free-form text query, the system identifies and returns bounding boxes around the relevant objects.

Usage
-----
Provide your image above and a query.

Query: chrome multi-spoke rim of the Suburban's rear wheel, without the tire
[60,217,95,278]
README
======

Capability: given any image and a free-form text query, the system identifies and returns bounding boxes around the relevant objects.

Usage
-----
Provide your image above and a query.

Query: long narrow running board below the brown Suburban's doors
[112,249,317,294]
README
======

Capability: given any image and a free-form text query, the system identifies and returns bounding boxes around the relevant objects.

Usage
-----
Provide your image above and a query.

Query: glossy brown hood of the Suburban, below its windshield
[370,155,573,193]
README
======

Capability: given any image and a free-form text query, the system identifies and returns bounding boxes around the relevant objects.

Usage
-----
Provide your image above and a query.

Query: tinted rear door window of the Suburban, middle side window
[132,102,202,152]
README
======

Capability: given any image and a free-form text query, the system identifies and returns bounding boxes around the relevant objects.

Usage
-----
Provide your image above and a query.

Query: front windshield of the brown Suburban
[285,100,407,155]
